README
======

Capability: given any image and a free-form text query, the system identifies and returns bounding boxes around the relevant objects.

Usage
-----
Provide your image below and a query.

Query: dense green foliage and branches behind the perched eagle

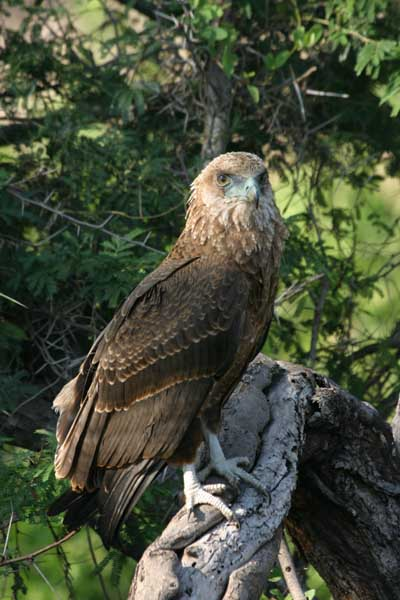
[0,0,400,598]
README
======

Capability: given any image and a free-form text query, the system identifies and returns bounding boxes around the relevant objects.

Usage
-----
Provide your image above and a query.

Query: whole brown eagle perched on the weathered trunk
[49,152,286,546]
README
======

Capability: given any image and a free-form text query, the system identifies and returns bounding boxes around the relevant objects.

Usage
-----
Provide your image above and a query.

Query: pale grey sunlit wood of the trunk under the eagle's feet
[129,356,312,600]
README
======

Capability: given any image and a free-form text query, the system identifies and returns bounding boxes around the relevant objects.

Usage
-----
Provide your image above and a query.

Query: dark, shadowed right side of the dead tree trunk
[287,372,400,600]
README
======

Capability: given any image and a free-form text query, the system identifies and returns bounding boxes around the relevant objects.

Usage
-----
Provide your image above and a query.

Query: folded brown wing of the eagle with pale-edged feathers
[56,259,249,489]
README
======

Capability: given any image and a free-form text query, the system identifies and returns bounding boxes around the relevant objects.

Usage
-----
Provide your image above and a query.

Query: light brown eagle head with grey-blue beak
[185,152,281,254]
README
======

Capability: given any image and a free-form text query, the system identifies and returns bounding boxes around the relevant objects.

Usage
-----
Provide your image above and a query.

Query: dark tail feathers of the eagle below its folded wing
[48,459,165,548]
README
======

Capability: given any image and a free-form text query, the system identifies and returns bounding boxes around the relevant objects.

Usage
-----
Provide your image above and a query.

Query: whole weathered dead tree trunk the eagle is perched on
[129,355,400,600]
